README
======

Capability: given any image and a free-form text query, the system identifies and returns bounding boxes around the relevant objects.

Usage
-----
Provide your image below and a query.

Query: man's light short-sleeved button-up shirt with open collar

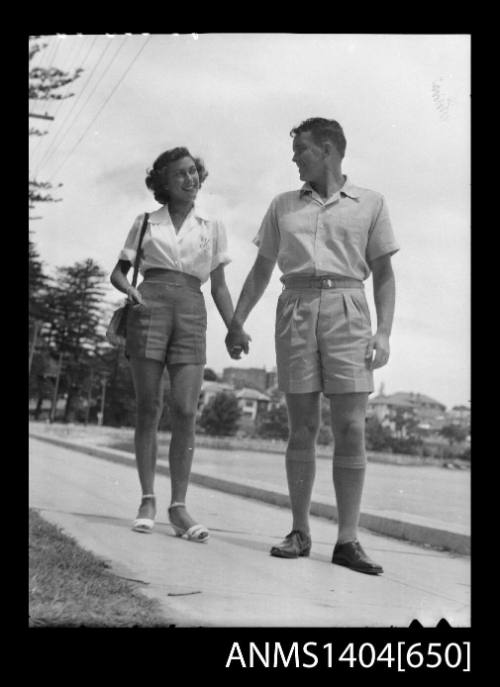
[254,179,399,280]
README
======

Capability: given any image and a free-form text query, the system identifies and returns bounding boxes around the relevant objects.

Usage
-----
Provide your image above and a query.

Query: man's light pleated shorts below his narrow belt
[275,284,373,394]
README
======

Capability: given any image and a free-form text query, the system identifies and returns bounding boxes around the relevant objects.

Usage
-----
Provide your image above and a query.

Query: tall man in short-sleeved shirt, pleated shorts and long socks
[226,117,399,574]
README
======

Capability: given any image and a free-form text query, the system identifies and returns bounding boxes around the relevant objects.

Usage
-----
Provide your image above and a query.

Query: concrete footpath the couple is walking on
[29,433,470,627]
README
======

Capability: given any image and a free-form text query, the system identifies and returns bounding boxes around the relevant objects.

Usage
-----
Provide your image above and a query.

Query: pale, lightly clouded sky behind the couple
[30,33,470,408]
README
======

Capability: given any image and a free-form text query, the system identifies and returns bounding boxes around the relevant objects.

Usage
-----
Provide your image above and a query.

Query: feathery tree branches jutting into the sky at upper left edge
[29,36,83,210]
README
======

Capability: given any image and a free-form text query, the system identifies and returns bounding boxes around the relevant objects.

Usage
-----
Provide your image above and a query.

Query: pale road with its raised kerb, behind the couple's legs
[30,424,470,555]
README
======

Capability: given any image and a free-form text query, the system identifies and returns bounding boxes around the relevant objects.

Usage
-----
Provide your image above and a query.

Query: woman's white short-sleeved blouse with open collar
[118,205,231,283]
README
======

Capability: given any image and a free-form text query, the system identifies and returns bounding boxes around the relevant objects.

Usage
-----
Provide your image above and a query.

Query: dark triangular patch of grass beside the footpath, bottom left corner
[29,509,169,627]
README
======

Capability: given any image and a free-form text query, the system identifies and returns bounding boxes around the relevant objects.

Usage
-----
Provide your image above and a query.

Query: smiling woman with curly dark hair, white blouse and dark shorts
[111,148,249,542]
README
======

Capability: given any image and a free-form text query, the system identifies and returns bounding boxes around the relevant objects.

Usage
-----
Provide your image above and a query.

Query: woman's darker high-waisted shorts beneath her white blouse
[126,269,207,365]
